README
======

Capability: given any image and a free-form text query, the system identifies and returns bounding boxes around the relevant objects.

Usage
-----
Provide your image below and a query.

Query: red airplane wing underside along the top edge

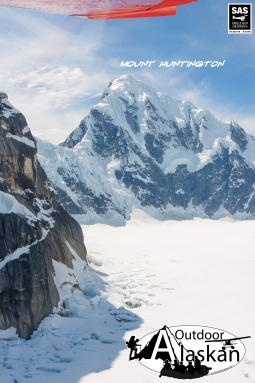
[0,0,196,20]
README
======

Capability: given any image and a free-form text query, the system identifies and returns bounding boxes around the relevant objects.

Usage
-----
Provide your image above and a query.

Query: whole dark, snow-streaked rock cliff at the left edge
[0,98,86,338]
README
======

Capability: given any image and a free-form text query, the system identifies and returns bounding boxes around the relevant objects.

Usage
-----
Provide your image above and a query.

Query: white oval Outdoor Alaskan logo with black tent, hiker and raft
[126,326,250,379]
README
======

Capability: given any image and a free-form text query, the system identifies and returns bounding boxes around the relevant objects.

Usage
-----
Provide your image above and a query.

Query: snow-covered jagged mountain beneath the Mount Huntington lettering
[38,75,255,222]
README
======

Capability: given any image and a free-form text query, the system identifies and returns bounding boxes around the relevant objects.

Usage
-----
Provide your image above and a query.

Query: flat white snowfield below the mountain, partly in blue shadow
[0,210,255,383]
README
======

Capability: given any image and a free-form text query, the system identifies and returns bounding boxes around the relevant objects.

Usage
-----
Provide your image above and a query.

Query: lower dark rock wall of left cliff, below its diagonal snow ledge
[0,241,59,338]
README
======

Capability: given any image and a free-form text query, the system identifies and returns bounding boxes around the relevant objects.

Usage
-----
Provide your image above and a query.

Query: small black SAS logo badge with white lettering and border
[228,3,252,33]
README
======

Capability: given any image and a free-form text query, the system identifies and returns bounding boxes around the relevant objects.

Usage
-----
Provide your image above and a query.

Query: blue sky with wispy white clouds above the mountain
[0,0,255,143]
